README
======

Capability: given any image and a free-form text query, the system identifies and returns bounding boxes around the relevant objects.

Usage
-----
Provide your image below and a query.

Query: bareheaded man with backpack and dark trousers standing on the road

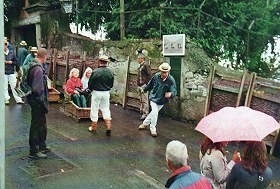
[27,48,50,158]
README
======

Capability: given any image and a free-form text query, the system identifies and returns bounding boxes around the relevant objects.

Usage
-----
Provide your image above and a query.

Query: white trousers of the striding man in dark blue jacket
[143,101,163,131]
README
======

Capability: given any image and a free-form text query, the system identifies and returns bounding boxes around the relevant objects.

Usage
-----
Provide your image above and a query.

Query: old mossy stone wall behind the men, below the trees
[56,34,211,120]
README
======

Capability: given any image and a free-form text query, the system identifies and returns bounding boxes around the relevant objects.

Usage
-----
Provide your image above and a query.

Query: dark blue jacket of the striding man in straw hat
[144,73,177,105]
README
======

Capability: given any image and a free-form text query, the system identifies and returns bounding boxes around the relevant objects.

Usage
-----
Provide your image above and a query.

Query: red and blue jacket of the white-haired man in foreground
[165,166,213,189]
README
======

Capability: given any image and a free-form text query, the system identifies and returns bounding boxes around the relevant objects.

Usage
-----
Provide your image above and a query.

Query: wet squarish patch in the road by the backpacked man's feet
[19,152,79,179]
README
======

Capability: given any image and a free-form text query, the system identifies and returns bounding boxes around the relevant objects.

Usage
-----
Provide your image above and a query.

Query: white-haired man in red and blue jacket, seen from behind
[165,140,212,189]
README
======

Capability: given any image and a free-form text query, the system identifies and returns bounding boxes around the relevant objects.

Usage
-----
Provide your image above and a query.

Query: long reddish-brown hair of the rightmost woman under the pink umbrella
[241,141,268,174]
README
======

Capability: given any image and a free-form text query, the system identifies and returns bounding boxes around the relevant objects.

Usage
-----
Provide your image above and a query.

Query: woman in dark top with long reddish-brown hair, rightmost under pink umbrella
[226,141,272,189]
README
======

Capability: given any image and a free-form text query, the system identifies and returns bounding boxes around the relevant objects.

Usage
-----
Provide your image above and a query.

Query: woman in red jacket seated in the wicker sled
[66,68,87,108]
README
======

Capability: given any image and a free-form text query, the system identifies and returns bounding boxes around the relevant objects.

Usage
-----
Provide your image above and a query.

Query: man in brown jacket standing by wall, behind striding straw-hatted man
[137,53,152,120]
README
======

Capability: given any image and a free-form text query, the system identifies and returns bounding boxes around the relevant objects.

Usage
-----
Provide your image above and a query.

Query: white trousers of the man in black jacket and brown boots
[90,91,111,122]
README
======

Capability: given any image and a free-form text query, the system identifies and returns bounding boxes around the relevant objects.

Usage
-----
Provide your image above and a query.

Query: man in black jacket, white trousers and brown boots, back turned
[88,55,114,136]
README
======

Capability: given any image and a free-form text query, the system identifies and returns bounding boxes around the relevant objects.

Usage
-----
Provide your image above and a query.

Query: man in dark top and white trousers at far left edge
[4,40,24,104]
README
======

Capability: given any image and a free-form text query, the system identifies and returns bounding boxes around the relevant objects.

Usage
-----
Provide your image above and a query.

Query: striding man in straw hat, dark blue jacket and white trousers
[139,62,177,137]
